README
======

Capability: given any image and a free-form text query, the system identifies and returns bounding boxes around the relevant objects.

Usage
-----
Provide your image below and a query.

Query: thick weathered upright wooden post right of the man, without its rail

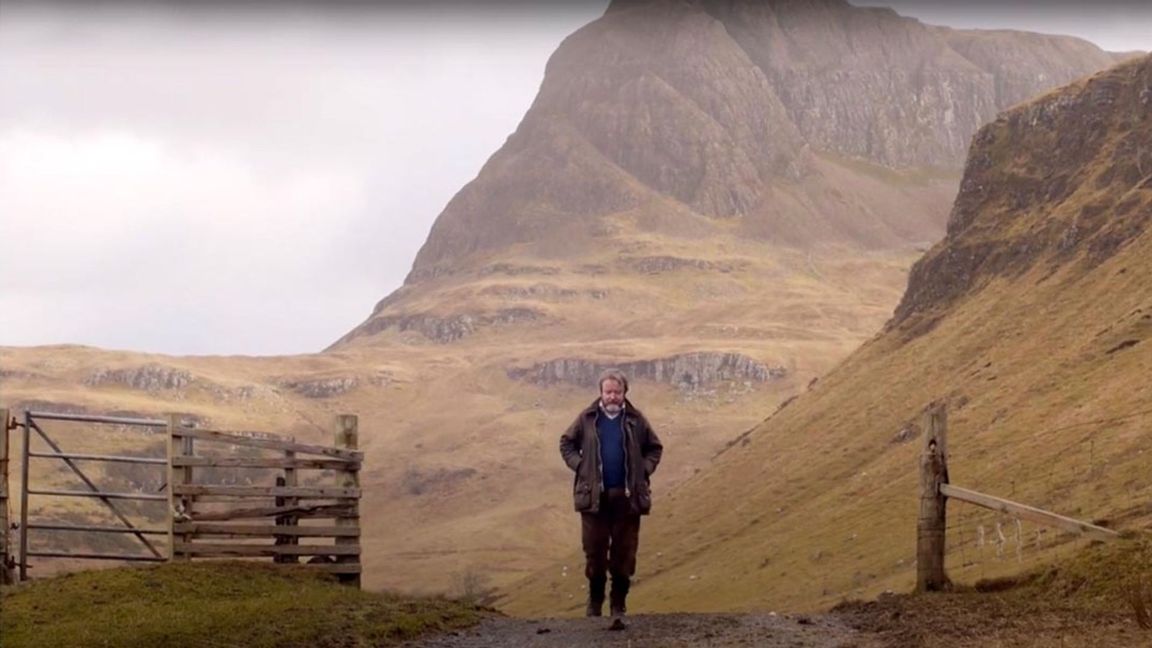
[916,404,950,592]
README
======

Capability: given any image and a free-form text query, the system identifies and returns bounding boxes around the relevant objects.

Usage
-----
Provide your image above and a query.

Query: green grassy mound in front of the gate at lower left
[0,562,492,648]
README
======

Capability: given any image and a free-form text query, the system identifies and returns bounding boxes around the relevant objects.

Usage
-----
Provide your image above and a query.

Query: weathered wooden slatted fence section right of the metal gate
[168,415,363,586]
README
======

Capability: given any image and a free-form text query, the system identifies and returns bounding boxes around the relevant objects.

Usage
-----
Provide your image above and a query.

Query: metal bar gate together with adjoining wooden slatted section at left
[0,409,363,587]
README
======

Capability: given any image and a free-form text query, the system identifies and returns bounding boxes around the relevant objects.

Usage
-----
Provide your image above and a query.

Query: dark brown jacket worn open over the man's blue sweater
[560,399,664,515]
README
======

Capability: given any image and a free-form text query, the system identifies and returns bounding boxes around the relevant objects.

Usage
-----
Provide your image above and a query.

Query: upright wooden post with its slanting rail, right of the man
[916,404,1120,592]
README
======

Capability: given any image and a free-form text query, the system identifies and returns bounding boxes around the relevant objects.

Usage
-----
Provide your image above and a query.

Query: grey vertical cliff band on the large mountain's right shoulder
[705,0,1115,168]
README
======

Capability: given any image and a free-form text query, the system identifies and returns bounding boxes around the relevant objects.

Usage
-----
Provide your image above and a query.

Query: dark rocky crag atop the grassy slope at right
[890,56,1152,326]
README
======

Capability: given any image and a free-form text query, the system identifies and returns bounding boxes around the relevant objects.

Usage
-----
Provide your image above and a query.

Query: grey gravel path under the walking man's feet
[406,613,864,648]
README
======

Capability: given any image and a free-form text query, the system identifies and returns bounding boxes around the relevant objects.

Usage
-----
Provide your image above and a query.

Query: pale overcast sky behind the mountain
[0,0,1152,355]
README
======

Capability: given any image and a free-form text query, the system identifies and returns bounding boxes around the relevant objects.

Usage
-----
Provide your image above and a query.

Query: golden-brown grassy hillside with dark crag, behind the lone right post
[506,56,1152,611]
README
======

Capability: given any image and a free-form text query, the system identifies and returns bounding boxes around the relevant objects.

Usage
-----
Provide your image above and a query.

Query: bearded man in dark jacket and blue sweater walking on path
[560,369,664,628]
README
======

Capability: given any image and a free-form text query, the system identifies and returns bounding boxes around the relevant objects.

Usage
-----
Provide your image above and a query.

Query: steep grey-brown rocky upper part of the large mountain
[393,0,1114,284]
